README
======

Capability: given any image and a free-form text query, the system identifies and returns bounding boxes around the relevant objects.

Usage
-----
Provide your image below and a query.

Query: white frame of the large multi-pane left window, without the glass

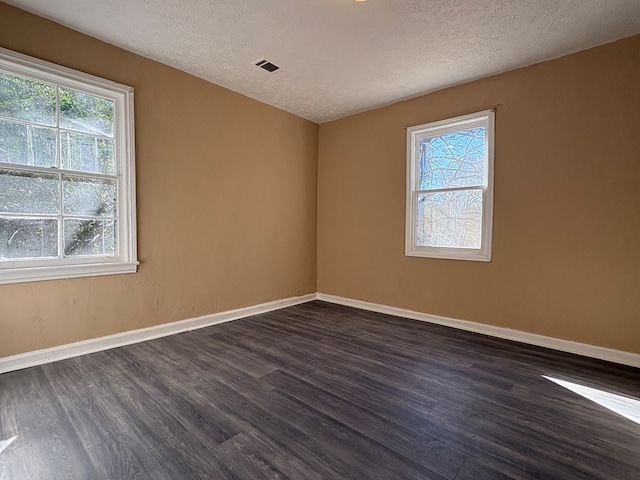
[0,48,138,284]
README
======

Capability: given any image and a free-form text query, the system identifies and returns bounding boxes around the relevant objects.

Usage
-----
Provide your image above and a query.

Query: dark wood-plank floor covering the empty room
[0,302,640,480]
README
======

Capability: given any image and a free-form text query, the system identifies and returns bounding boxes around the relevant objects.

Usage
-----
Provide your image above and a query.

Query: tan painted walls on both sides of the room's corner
[0,3,640,357]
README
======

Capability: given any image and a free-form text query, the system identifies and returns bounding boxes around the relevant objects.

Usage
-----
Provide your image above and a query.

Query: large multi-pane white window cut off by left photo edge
[0,49,137,283]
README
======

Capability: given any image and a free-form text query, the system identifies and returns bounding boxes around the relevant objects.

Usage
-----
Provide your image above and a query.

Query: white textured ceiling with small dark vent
[4,0,640,123]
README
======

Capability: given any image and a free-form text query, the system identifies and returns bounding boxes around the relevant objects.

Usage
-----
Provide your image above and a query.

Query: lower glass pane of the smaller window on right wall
[416,190,482,248]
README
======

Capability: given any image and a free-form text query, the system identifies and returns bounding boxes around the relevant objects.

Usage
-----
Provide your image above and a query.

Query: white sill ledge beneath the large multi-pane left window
[0,262,139,285]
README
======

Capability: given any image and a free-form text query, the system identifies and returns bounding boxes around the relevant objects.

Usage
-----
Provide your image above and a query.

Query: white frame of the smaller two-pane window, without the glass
[405,110,495,262]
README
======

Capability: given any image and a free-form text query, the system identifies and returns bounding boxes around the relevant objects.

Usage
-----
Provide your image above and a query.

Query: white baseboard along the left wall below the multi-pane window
[0,293,318,373]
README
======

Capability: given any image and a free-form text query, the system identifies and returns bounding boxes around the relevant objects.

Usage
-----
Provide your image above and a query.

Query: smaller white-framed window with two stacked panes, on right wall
[405,110,494,262]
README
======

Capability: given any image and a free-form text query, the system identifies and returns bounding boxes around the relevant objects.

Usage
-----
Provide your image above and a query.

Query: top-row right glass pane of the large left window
[60,88,114,137]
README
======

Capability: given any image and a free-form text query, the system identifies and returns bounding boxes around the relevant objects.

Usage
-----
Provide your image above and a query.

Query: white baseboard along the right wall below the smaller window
[318,293,640,368]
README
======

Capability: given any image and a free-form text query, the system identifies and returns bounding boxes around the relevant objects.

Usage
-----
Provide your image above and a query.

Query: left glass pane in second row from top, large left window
[0,120,56,167]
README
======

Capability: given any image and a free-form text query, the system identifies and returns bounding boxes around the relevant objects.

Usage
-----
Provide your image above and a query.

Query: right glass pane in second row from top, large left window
[60,132,115,175]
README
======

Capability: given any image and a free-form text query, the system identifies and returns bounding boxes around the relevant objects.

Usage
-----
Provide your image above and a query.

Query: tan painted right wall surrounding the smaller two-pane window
[318,36,640,353]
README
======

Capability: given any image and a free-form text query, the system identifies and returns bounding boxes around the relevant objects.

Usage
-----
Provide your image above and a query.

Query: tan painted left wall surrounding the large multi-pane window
[0,3,318,357]
